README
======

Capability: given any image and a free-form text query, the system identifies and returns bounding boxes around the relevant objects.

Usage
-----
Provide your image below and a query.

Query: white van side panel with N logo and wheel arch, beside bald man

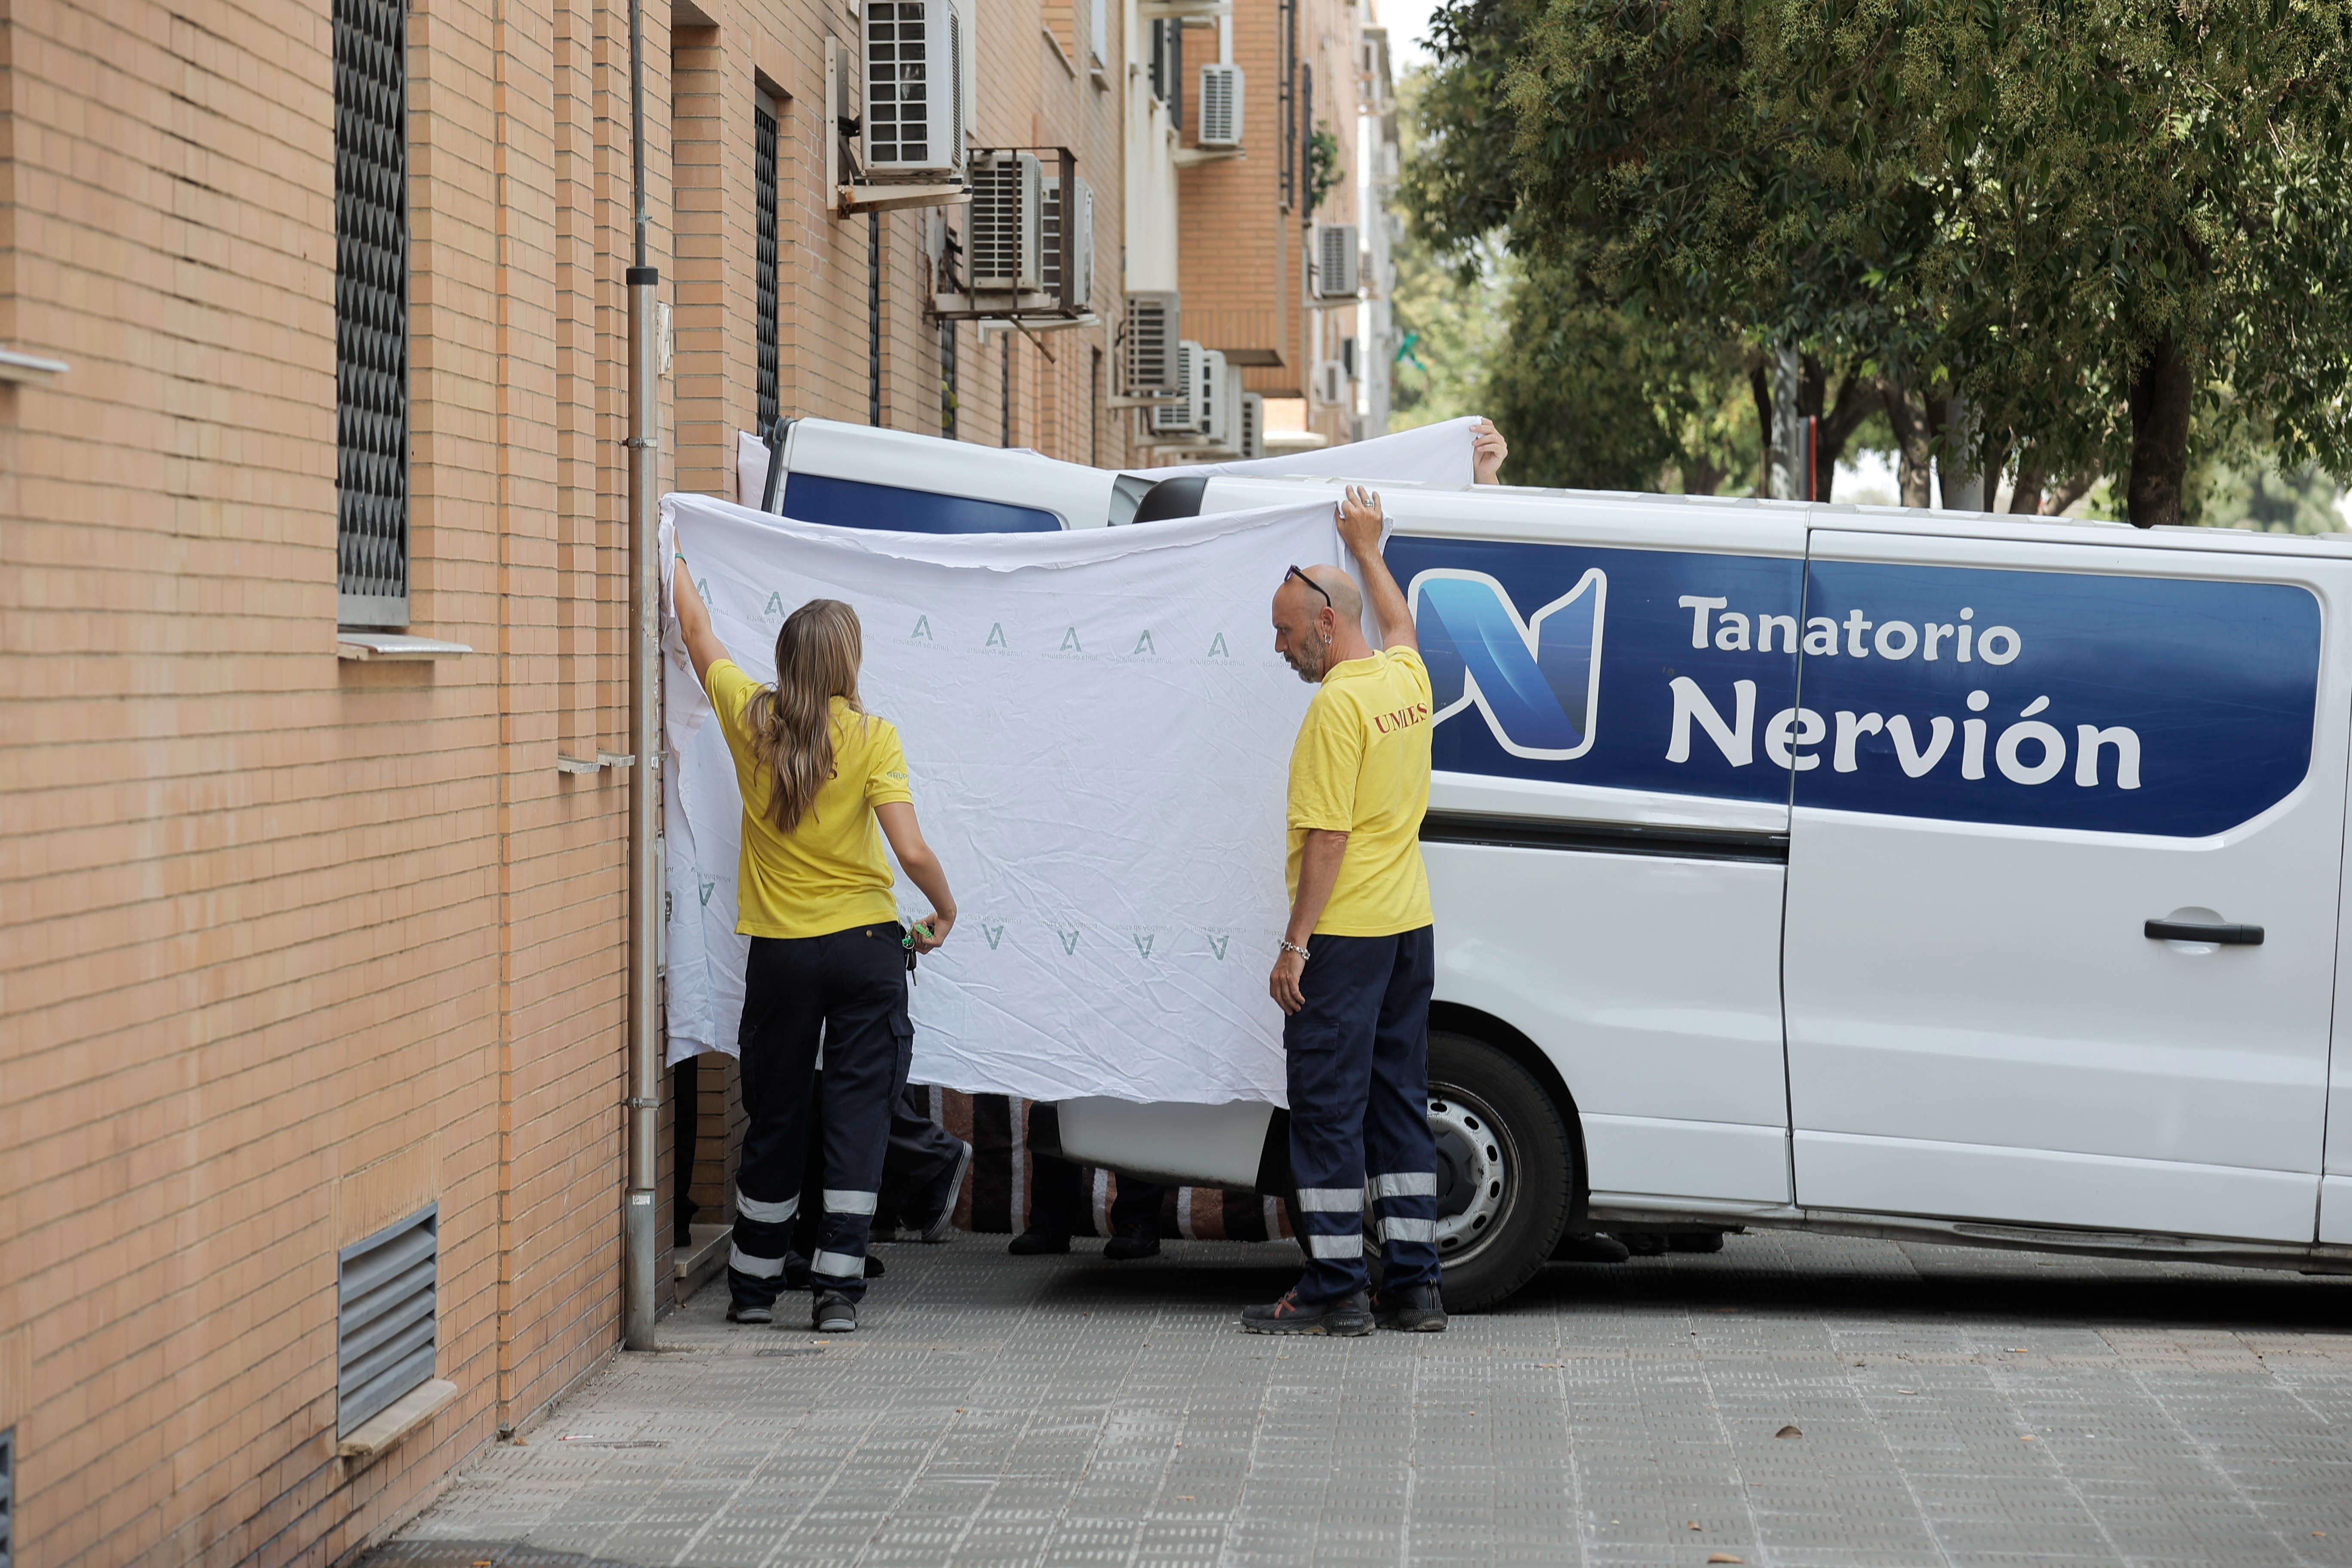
[1387,489,1804,1216]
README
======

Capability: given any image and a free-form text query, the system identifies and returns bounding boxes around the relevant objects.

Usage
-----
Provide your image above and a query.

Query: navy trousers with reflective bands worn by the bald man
[1282,926,1437,1302]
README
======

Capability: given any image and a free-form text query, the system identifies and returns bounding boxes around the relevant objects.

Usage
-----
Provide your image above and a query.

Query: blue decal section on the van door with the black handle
[1788,562,2321,837]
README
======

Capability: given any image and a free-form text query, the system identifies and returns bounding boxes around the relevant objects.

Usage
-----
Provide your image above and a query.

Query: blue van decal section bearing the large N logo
[1387,534,1804,802]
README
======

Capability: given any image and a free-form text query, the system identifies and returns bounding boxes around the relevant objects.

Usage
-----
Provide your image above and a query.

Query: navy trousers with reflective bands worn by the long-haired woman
[727,924,915,1307]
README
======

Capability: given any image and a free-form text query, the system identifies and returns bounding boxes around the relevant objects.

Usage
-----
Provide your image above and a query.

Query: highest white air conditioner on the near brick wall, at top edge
[861,0,974,179]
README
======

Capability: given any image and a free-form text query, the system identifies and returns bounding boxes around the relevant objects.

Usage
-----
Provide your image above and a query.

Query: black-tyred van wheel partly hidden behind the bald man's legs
[1430,1030,1576,1312]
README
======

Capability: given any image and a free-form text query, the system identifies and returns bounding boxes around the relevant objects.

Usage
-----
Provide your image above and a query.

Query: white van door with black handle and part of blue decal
[1785,527,2352,1243]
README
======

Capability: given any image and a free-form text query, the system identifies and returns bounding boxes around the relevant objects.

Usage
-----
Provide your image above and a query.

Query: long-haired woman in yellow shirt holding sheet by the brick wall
[673,555,955,1333]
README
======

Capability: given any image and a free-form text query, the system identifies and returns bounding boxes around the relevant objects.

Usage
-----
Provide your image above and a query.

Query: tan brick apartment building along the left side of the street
[0,0,1383,1568]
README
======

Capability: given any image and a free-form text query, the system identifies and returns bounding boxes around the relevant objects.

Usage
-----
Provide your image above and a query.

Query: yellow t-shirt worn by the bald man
[1289,649,1432,936]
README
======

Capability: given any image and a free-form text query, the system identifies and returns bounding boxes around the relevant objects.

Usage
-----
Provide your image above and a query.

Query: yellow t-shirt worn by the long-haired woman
[706,658,915,936]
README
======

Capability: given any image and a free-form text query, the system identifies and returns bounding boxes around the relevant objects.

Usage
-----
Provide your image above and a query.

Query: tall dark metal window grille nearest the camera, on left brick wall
[334,0,409,625]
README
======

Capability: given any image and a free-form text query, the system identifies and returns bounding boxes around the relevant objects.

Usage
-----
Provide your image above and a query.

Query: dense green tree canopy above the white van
[1404,0,2352,520]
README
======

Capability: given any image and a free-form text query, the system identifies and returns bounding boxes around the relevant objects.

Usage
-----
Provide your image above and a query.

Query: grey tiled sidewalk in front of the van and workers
[364,1234,2352,1568]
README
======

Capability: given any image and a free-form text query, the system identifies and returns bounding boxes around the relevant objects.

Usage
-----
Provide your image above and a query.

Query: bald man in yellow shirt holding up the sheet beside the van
[1242,487,1446,1335]
